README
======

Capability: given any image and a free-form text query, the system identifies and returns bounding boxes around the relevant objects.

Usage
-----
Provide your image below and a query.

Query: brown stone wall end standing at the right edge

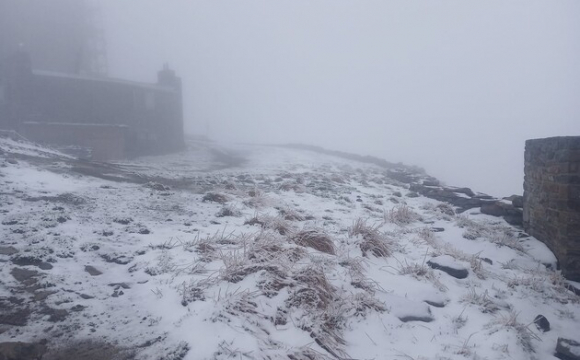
[524,136,580,281]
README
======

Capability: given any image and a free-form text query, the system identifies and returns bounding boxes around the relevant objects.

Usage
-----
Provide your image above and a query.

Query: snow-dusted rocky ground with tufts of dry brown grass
[0,138,580,360]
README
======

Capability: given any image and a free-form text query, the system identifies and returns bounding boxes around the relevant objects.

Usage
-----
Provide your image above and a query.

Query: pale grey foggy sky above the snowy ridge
[100,0,580,196]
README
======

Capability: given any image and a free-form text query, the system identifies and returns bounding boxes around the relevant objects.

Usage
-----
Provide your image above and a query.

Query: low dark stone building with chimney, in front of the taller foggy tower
[0,52,184,160]
